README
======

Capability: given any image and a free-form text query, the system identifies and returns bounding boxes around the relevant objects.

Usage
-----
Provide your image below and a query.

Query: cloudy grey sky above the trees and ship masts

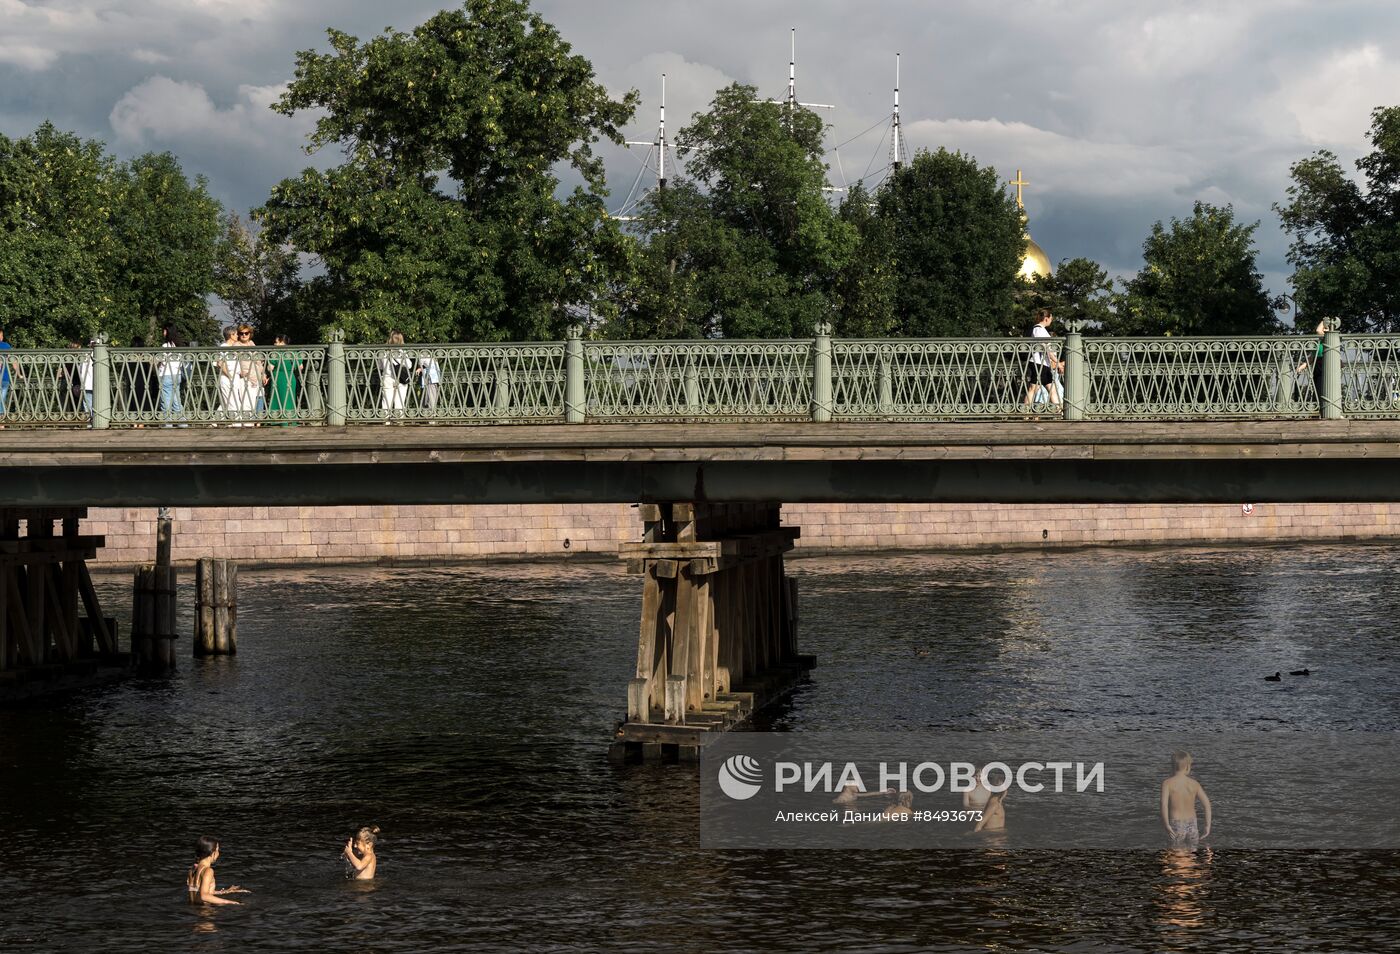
[0,0,1400,308]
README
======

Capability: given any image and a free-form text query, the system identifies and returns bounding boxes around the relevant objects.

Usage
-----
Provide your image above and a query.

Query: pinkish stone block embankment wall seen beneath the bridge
[83,503,1400,566]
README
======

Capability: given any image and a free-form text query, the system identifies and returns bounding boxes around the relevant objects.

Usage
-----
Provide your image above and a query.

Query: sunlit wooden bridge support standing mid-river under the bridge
[612,503,813,759]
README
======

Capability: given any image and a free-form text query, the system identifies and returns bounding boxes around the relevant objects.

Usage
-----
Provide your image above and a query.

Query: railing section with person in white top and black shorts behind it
[832,338,1064,420]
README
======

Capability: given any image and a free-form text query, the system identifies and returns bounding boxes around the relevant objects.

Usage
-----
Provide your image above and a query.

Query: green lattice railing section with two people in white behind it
[344,342,564,423]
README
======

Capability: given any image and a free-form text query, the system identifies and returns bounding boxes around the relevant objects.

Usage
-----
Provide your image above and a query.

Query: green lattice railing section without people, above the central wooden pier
[584,340,812,420]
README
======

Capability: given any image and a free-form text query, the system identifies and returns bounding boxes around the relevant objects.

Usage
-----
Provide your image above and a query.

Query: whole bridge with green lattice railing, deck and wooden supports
[0,331,1400,756]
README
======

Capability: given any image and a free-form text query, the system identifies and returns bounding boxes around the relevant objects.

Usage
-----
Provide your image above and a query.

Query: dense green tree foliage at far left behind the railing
[0,123,220,347]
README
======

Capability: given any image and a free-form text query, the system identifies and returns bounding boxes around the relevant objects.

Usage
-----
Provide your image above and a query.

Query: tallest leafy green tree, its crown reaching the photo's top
[255,0,636,340]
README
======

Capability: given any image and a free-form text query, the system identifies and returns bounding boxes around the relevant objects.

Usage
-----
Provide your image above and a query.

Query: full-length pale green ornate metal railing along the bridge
[0,326,1377,429]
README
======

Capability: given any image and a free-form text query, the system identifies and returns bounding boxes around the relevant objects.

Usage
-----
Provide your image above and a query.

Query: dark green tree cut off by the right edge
[1274,106,1400,332]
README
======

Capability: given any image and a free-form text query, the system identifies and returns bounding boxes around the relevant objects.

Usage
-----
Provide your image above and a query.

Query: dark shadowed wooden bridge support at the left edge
[0,507,126,698]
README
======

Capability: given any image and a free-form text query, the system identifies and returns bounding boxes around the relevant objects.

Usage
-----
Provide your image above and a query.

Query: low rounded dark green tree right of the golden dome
[1109,202,1278,335]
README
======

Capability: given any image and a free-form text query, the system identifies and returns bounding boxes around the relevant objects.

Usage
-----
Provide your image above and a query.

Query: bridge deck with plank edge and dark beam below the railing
[8,420,1400,506]
